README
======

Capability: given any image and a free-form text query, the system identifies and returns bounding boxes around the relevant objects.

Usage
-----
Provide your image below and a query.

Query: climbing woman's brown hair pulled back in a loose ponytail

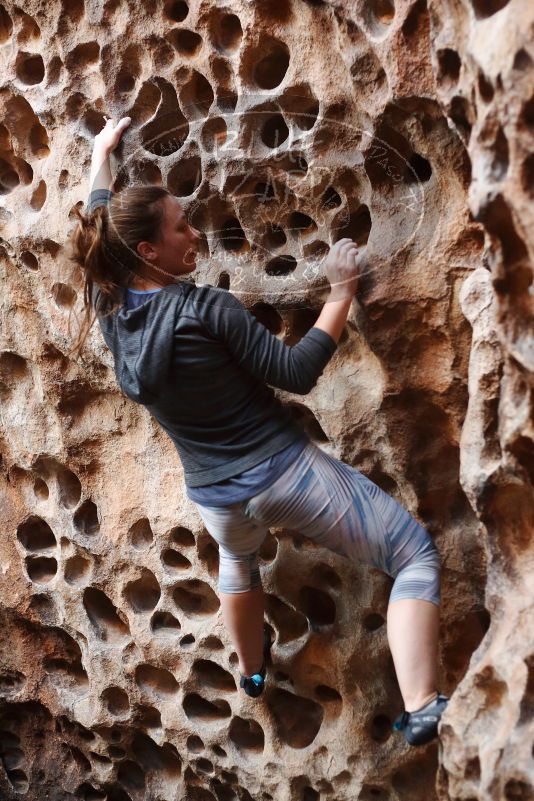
[68,186,171,356]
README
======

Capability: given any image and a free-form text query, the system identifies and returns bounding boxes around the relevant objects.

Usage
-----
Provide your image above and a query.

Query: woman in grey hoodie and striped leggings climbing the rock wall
[71,117,449,745]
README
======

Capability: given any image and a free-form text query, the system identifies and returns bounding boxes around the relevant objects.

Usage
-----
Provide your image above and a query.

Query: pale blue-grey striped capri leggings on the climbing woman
[195,442,440,606]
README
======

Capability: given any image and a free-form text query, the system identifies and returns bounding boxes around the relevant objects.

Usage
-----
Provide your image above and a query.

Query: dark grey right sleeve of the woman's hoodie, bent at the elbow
[198,285,337,395]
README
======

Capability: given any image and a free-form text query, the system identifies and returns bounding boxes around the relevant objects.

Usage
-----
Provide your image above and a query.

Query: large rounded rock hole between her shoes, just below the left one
[267,688,324,748]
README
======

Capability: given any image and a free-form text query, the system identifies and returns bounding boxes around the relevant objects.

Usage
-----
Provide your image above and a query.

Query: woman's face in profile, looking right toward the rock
[137,195,200,275]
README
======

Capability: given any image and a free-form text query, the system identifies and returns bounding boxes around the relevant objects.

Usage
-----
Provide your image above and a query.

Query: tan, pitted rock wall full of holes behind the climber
[0,0,534,801]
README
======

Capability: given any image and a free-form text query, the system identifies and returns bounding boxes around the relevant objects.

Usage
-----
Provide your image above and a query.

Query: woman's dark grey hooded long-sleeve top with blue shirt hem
[86,190,337,487]
